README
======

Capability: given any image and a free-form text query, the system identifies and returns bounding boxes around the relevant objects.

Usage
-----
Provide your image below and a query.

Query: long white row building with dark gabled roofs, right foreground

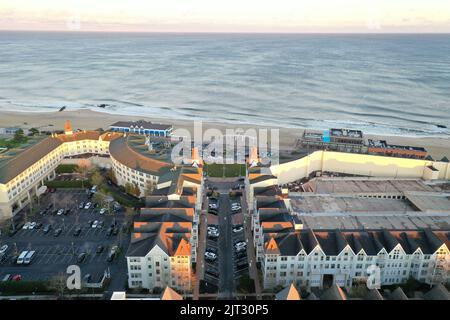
[262,229,450,289]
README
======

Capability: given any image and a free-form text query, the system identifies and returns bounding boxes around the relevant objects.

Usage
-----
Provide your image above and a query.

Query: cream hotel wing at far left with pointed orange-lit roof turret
[0,122,121,220]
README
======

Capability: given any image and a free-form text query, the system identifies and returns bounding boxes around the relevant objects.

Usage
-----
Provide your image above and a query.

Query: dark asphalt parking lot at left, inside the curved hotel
[0,189,128,282]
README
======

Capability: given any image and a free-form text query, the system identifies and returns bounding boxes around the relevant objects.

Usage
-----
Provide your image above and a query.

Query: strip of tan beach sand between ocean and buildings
[0,109,450,160]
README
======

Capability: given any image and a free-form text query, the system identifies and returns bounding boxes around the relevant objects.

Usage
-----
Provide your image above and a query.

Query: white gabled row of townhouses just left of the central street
[126,151,203,292]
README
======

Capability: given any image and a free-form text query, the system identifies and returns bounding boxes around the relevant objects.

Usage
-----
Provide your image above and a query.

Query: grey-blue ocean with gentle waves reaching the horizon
[0,32,450,136]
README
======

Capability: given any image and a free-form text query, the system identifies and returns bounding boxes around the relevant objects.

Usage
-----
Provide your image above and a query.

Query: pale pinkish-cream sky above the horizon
[0,0,450,33]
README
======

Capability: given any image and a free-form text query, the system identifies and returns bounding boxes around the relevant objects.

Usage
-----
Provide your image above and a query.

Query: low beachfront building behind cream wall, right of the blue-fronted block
[367,139,427,159]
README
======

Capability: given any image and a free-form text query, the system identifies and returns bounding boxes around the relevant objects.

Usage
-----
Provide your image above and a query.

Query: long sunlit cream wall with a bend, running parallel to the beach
[271,151,450,184]
